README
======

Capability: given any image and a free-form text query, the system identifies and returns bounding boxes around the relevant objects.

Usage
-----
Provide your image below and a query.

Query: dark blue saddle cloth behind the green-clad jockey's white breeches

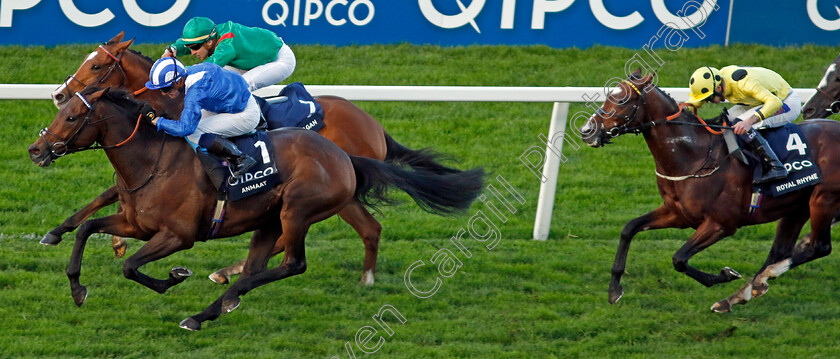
[254,82,324,131]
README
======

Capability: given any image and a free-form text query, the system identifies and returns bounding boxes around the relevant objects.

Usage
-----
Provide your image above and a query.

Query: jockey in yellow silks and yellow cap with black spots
[688,66,802,183]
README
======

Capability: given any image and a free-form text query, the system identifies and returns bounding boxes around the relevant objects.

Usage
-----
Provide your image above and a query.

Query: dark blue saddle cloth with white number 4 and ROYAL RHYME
[738,123,822,197]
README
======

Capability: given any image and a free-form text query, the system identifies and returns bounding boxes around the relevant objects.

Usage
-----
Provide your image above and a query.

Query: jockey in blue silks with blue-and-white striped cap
[146,58,260,178]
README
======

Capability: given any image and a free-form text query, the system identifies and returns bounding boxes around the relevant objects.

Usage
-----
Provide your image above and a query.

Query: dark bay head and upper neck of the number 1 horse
[28,87,155,167]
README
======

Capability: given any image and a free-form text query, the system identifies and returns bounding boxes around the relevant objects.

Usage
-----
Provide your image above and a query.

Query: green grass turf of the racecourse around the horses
[0,43,840,358]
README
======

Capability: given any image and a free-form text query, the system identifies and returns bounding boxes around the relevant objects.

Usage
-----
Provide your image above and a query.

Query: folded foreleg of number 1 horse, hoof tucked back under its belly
[123,230,195,294]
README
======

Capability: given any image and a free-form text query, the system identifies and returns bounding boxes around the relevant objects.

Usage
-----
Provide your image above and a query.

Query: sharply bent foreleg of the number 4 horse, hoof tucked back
[673,219,741,287]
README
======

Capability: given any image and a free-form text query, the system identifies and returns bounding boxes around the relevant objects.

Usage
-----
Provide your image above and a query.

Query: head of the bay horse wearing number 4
[579,71,655,147]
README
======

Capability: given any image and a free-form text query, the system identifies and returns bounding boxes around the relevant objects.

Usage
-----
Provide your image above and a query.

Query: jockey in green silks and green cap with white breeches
[161,17,297,91]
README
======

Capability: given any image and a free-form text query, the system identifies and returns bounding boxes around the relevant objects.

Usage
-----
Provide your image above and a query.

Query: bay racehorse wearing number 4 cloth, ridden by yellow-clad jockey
[579,72,840,312]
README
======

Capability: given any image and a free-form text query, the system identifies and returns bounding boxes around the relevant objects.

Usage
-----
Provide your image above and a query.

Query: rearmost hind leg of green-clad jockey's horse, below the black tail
[338,201,382,286]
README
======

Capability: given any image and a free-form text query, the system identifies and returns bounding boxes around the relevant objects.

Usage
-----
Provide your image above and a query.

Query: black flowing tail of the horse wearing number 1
[350,156,484,215]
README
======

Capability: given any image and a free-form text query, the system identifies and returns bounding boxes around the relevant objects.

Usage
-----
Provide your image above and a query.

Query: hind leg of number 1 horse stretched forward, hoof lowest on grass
[179,221,309,331]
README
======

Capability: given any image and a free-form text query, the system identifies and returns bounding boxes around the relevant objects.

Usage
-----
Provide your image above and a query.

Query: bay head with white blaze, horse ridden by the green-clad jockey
[51,32,134,108]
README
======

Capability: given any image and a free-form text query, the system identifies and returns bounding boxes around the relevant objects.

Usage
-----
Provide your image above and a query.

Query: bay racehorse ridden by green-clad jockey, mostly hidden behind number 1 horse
[47,32,461,285]
